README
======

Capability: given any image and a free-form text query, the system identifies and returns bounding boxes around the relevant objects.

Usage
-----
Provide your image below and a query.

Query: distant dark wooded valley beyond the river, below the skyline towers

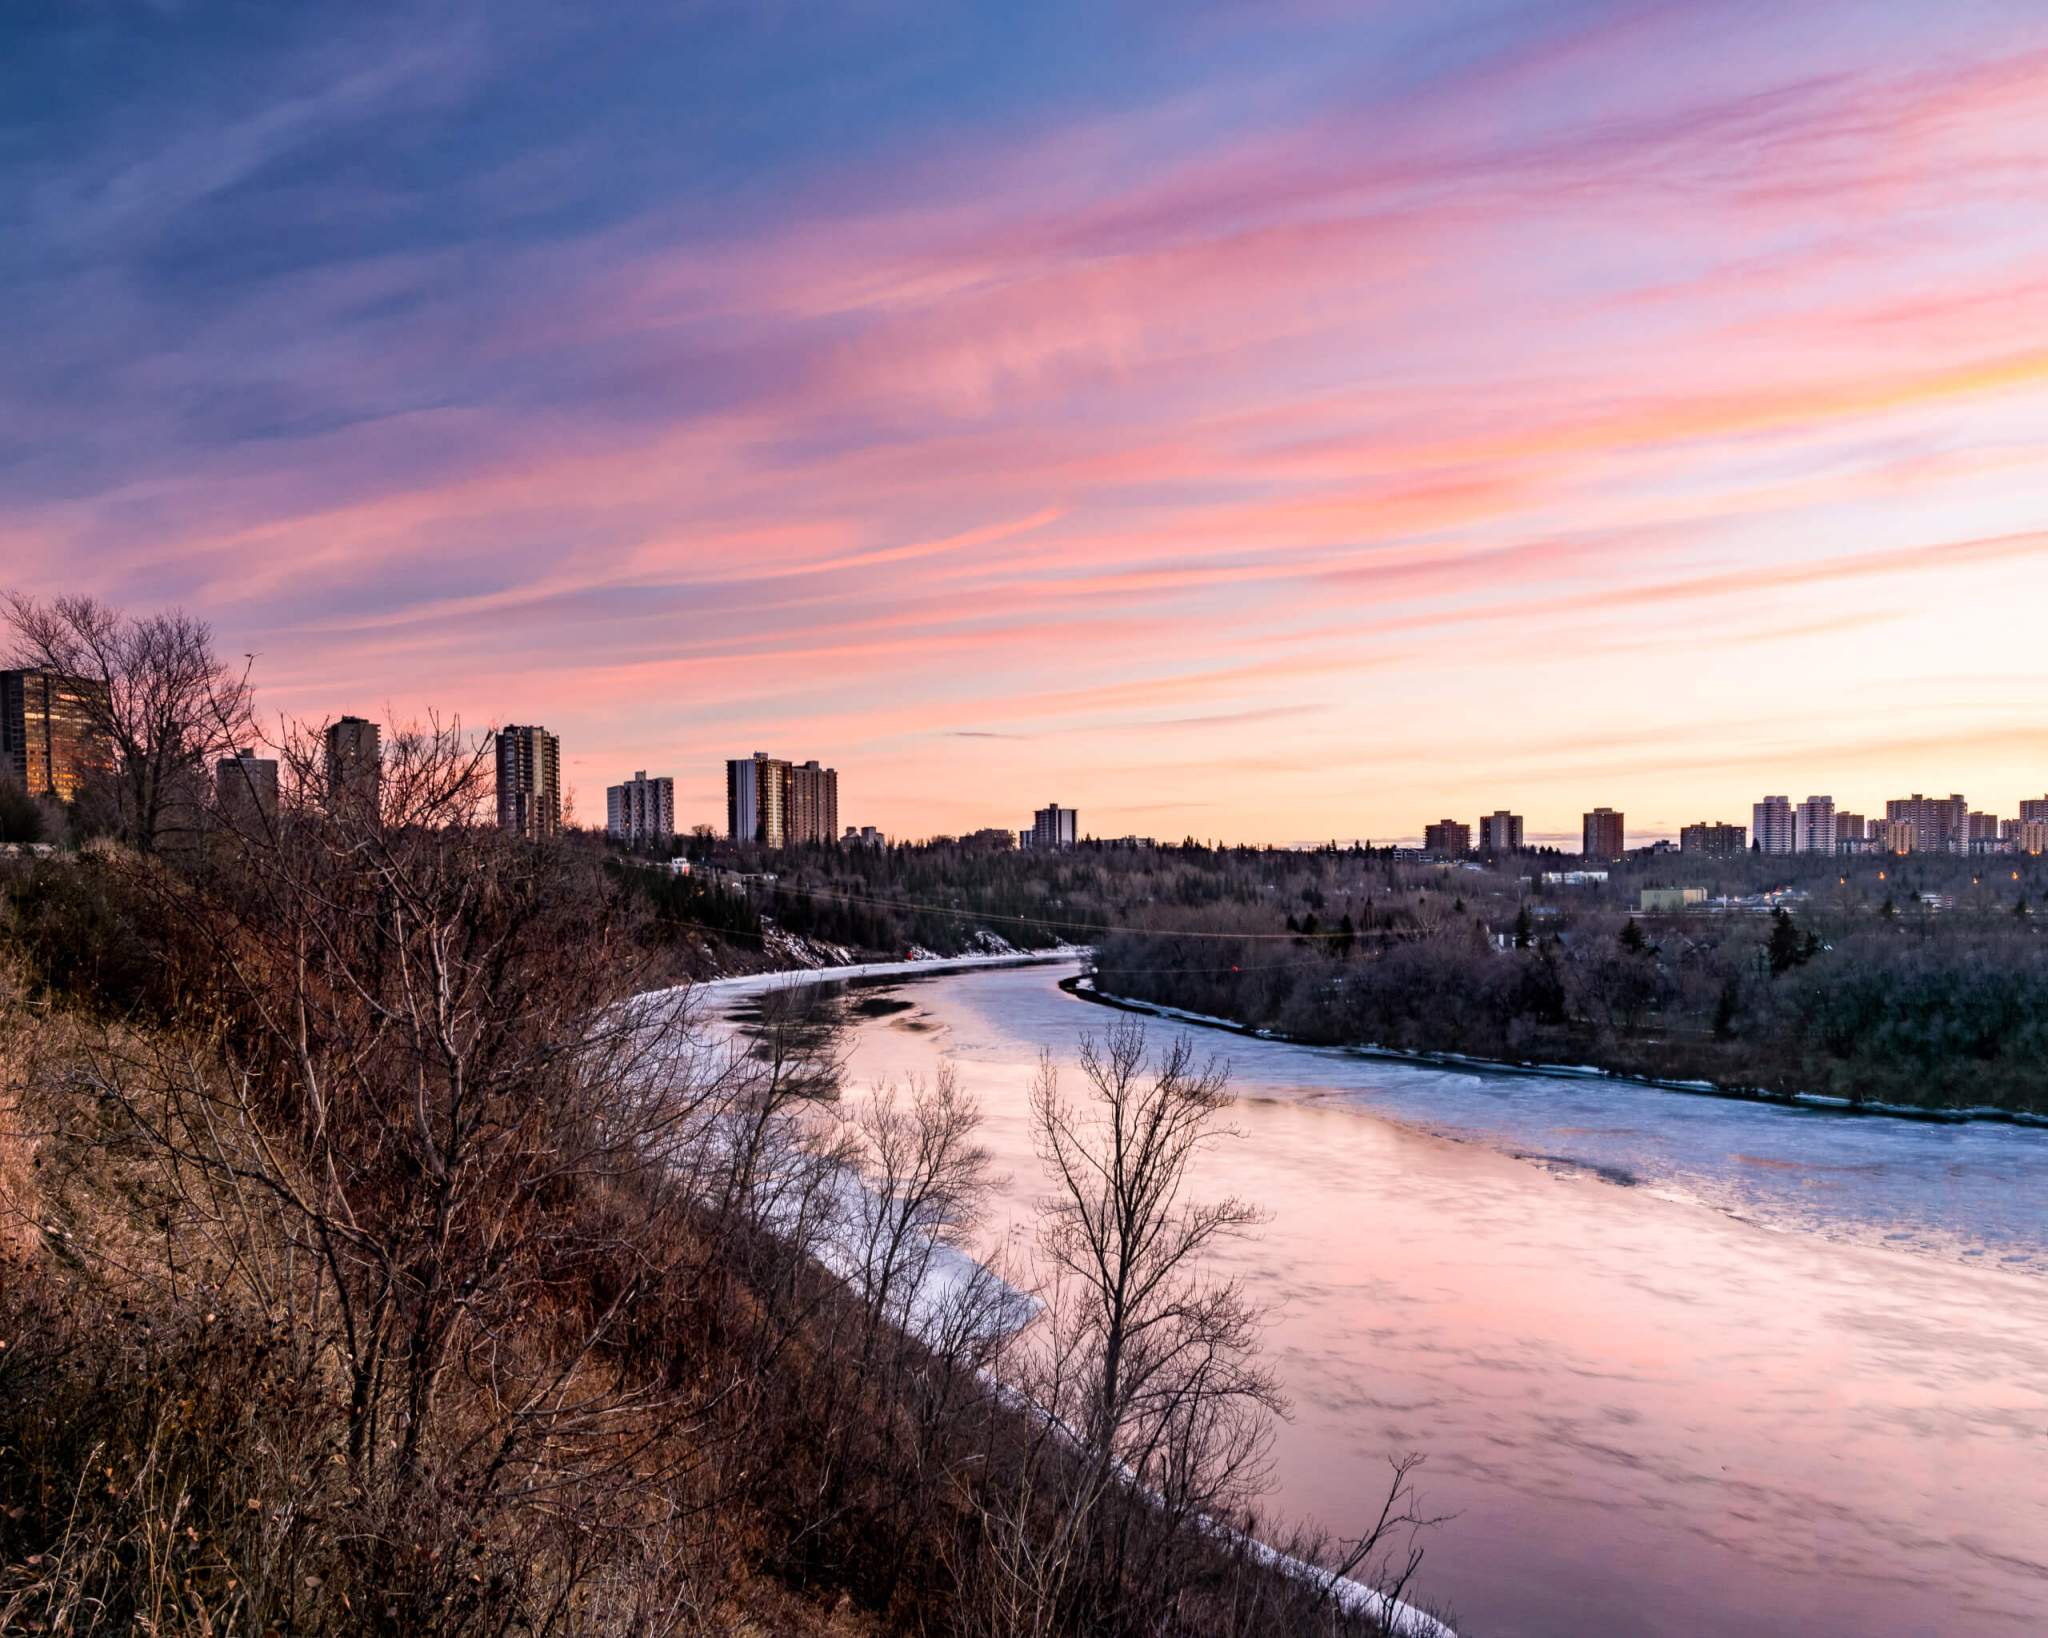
[633,831,2048,1110]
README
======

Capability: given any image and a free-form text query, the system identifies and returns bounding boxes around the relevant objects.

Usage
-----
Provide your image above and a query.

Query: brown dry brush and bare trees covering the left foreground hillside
[0,597,1441,1638]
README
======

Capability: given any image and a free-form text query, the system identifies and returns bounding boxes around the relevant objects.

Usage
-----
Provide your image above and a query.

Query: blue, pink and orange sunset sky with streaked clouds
[0,0,2048,846]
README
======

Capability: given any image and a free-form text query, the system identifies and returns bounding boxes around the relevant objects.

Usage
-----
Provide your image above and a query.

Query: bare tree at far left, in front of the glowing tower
[4,592,252,854]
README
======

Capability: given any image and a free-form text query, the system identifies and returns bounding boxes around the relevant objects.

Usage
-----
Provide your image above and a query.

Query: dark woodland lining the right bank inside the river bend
[1096,885,2048,1112]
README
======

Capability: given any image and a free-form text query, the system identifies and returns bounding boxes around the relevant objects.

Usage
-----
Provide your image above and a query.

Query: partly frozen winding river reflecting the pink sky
[708,966,2048,1638]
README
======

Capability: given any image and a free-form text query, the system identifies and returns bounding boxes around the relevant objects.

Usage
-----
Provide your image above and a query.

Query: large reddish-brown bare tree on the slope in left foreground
[12,712,819,1630]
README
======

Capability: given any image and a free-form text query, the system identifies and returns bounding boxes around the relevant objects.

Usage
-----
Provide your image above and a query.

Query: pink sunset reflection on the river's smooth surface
[774,975,2048,1638]
